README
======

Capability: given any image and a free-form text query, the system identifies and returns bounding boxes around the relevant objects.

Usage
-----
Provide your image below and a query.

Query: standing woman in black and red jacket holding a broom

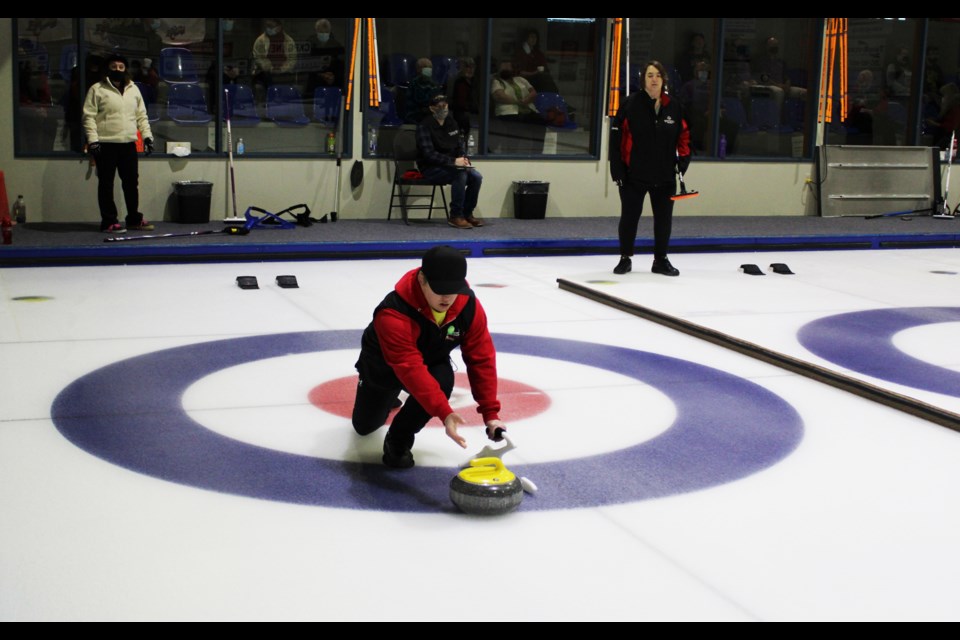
[610,60,690,276]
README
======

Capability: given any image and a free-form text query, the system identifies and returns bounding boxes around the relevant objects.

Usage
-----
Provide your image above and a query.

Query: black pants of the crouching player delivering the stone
[353,361,453,450]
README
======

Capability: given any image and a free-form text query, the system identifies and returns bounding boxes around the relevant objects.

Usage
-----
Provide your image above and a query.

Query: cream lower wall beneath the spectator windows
[0,18,836,222]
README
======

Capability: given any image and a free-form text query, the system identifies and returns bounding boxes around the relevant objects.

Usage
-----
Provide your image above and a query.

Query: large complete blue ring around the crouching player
[51,330,803,512]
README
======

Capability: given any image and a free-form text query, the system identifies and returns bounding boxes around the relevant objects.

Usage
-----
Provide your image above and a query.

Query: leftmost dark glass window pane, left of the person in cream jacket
[14,18,76,155]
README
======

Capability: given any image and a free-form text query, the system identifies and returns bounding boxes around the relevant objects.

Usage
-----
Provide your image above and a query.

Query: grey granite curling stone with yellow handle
[450,458,523,516]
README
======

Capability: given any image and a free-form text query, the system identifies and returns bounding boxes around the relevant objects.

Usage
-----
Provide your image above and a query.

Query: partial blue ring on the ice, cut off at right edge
[797,307,960,398]
